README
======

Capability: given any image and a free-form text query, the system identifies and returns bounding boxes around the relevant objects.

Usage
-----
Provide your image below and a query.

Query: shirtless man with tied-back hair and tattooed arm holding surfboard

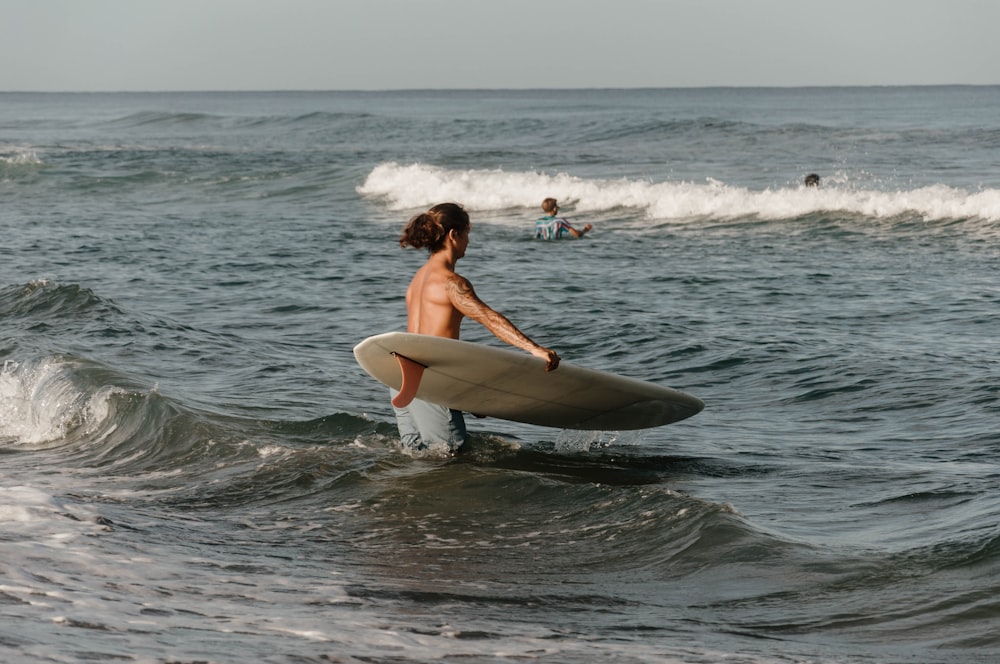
[393,203,559,453]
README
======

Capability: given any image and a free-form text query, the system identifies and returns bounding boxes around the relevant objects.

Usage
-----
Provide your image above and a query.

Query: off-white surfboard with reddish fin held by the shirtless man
[354,332,705,431]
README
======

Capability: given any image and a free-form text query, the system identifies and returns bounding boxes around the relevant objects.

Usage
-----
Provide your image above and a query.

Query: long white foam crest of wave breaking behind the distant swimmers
[357,162,1000,223]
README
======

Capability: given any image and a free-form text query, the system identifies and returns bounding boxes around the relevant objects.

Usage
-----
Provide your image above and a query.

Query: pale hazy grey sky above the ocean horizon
[0,0,1000,91]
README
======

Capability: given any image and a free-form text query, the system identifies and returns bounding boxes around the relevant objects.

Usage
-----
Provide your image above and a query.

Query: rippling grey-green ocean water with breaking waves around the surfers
[0,87,1000,663]
